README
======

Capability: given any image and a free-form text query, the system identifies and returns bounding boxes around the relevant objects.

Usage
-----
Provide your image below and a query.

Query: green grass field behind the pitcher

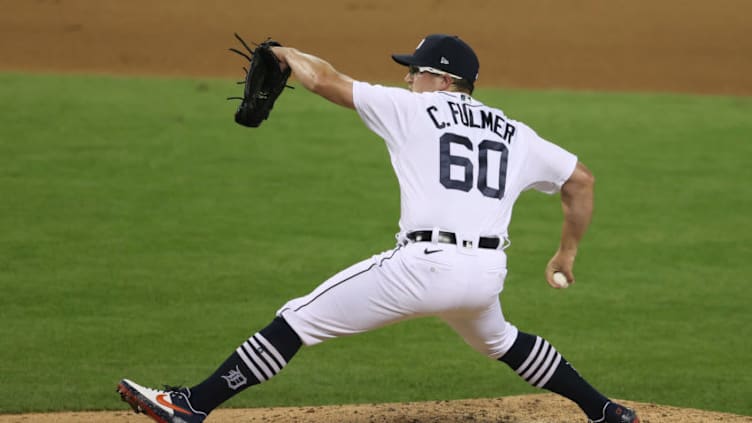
[0,74,752,415]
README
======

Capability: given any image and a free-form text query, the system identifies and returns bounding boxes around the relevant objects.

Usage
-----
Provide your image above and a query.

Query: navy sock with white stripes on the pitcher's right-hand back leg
[499,332,608,419]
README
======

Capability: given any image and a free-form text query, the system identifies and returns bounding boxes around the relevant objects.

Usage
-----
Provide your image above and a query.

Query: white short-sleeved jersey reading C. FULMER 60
[353,82,577,242]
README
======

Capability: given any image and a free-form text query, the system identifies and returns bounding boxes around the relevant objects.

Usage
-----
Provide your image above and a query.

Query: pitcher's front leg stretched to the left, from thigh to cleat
[118,243,420,422]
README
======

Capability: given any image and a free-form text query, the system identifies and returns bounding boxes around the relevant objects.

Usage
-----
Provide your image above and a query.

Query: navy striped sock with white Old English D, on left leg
[190,317,302,413]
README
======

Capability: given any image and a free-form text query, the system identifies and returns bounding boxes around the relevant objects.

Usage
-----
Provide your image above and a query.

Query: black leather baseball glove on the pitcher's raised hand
[228,34,292,128]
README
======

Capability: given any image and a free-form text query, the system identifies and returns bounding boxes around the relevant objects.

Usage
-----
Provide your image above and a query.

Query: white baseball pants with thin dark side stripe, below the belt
[277,238,517,359]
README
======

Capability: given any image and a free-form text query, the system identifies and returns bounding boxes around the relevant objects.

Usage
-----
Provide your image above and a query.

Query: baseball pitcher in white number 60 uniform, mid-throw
[118,34,639,423]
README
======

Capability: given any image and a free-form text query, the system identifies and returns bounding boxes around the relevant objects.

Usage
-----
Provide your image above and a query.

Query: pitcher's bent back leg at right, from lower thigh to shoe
[442,300,639,423]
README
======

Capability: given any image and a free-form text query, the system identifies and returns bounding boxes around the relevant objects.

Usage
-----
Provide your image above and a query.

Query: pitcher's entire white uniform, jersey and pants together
[278,82,577,360]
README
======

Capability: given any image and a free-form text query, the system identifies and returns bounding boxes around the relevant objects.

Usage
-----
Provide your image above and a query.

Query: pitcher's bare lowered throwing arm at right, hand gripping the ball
[546,162,595,288]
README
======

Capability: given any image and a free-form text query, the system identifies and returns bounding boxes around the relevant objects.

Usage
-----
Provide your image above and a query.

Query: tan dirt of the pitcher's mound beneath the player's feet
[0,394,752,423]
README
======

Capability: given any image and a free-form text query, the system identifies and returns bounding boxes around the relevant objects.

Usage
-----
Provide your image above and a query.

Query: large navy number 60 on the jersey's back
[439,133,509,199]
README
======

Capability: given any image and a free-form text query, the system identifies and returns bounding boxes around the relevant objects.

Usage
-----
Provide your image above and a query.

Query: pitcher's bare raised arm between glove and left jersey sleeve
[272,47,355,109]
